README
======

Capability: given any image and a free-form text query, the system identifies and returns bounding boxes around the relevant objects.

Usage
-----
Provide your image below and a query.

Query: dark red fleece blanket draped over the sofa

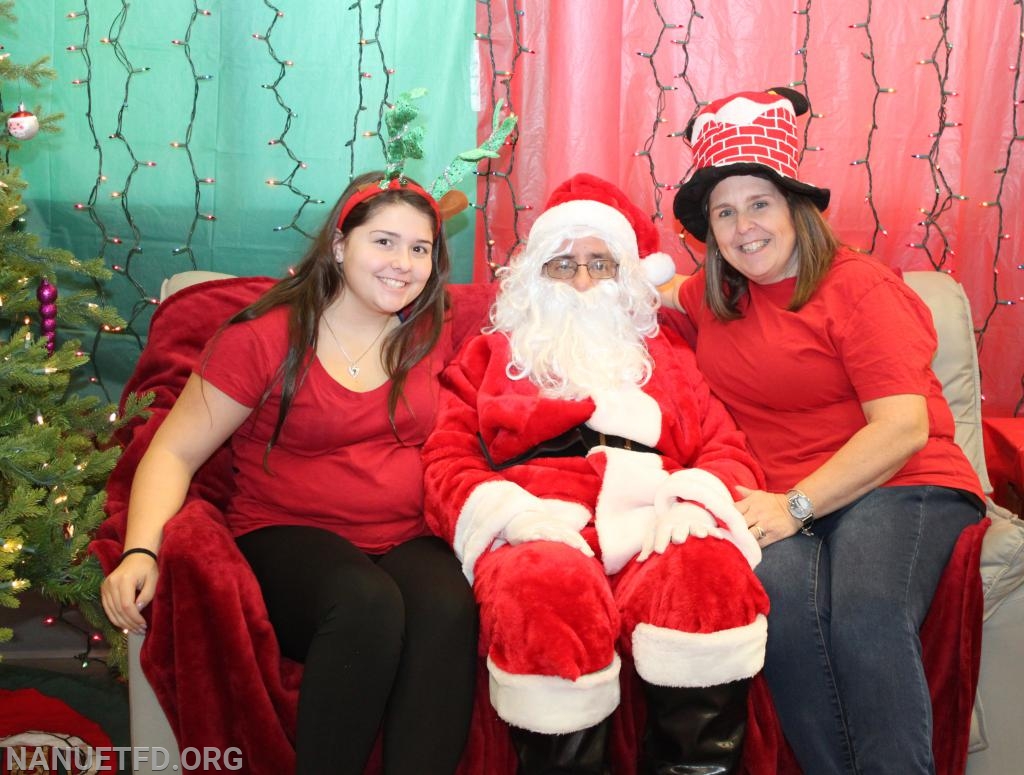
[91,277,987,775]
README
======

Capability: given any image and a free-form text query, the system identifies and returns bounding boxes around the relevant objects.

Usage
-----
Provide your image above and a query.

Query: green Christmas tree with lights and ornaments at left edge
[0,0,148,662]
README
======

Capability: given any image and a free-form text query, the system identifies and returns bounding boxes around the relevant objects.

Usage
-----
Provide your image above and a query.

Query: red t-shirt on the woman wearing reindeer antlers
[195,307,452,554]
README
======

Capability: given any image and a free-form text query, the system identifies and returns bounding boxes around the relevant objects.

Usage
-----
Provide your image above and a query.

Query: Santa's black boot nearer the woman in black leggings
[509,719,609,775]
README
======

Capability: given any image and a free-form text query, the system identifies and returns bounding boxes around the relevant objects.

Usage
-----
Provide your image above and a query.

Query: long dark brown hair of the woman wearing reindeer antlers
[226,172,451,456]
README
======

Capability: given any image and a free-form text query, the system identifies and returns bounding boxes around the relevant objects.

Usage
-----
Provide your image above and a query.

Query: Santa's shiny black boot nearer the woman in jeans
[640,679,750,775]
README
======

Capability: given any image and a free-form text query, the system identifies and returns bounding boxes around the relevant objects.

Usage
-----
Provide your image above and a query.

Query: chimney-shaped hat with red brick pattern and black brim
[672,87,829,242]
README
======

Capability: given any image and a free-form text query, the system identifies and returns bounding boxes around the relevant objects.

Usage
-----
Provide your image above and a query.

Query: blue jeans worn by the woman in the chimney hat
[756,485,981,775]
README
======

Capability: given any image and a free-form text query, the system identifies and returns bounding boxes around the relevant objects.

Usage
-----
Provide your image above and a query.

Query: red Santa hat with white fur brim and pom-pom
[529,173,676,286]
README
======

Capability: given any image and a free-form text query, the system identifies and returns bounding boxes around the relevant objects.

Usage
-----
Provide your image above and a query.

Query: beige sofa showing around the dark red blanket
[128,271,1024,775]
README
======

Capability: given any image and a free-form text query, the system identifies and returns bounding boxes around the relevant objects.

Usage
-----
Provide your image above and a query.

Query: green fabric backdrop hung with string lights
[16,0,479,397]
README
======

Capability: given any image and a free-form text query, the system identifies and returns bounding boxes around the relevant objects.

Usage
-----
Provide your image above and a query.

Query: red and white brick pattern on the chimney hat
[693,106,799,180]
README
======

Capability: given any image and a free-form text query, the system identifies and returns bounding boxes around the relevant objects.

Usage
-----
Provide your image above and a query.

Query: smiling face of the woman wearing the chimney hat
[708,175,797,285]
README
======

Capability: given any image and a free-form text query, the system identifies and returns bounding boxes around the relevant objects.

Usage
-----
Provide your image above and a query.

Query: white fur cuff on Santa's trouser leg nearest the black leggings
[487,654,622,735]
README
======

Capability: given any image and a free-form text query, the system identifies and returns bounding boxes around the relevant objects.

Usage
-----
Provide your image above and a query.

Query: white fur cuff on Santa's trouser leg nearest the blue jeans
[633,613,768,687]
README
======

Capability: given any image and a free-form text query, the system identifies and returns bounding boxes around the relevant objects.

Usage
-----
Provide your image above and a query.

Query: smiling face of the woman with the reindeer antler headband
[334,203,433,314]
